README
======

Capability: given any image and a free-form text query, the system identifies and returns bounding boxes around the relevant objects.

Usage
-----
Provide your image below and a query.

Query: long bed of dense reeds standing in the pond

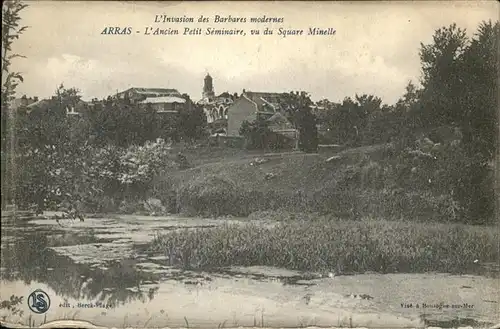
[153,216,499,274]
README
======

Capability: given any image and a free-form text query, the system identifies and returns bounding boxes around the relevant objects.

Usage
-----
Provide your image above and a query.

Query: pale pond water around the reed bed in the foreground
[0,216,500,327]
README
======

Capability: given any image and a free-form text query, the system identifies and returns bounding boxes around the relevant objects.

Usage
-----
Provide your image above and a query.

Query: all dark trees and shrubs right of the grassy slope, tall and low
[314,22,500,223]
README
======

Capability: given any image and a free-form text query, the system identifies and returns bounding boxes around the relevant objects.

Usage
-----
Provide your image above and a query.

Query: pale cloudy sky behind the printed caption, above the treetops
[7,0,500,104]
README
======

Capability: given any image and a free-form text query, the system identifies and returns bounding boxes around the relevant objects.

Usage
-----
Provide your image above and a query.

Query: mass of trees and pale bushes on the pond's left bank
[2,85,204,217]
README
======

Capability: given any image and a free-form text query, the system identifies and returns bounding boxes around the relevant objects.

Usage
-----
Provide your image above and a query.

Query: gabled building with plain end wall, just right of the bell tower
[227,90,298,139]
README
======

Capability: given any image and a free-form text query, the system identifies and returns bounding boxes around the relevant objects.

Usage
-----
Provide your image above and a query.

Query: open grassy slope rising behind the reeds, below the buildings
[150,145,451,220]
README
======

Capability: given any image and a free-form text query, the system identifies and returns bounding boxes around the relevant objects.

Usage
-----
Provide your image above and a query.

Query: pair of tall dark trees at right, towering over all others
[412,22,500,222]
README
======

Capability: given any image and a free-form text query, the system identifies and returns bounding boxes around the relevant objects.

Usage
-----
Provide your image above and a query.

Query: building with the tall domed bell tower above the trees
[197,74,237,126]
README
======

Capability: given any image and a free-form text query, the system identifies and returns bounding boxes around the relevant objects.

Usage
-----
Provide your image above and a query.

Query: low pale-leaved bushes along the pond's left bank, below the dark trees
[17,135,177,216]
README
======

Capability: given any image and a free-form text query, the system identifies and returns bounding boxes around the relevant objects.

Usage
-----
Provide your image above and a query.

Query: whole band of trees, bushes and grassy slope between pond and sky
[2,11,499,224]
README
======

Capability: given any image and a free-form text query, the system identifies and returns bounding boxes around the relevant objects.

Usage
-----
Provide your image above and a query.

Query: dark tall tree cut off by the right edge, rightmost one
[454,22,500,221]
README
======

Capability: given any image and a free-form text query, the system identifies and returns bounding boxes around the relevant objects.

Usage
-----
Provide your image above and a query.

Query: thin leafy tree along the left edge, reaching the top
[1,0,28,208]
